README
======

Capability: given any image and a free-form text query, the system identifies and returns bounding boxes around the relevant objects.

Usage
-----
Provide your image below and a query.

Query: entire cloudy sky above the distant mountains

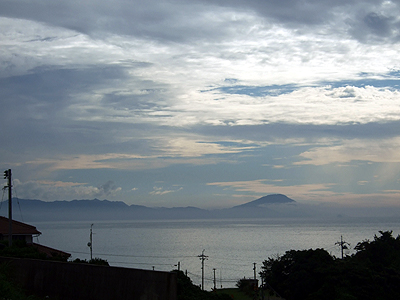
[0,0,400,208]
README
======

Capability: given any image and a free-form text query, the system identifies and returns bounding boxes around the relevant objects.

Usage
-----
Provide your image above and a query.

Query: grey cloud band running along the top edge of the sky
[0,0,400,42]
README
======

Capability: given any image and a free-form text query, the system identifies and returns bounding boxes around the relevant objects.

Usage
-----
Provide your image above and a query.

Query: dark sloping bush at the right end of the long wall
[174,270,232,300]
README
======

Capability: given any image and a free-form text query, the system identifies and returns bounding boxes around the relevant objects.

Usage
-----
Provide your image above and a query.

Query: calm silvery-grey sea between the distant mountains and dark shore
[33,219,400,290]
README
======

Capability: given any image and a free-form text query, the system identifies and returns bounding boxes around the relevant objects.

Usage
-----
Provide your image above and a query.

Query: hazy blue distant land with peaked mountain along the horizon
[0,194,400,222]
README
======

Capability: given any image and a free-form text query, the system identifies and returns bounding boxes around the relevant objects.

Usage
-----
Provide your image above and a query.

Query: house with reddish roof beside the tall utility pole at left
[0,216,71,259]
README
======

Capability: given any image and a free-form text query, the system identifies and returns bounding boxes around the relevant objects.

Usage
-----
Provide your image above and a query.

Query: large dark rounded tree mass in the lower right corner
[261,231,400,300]
